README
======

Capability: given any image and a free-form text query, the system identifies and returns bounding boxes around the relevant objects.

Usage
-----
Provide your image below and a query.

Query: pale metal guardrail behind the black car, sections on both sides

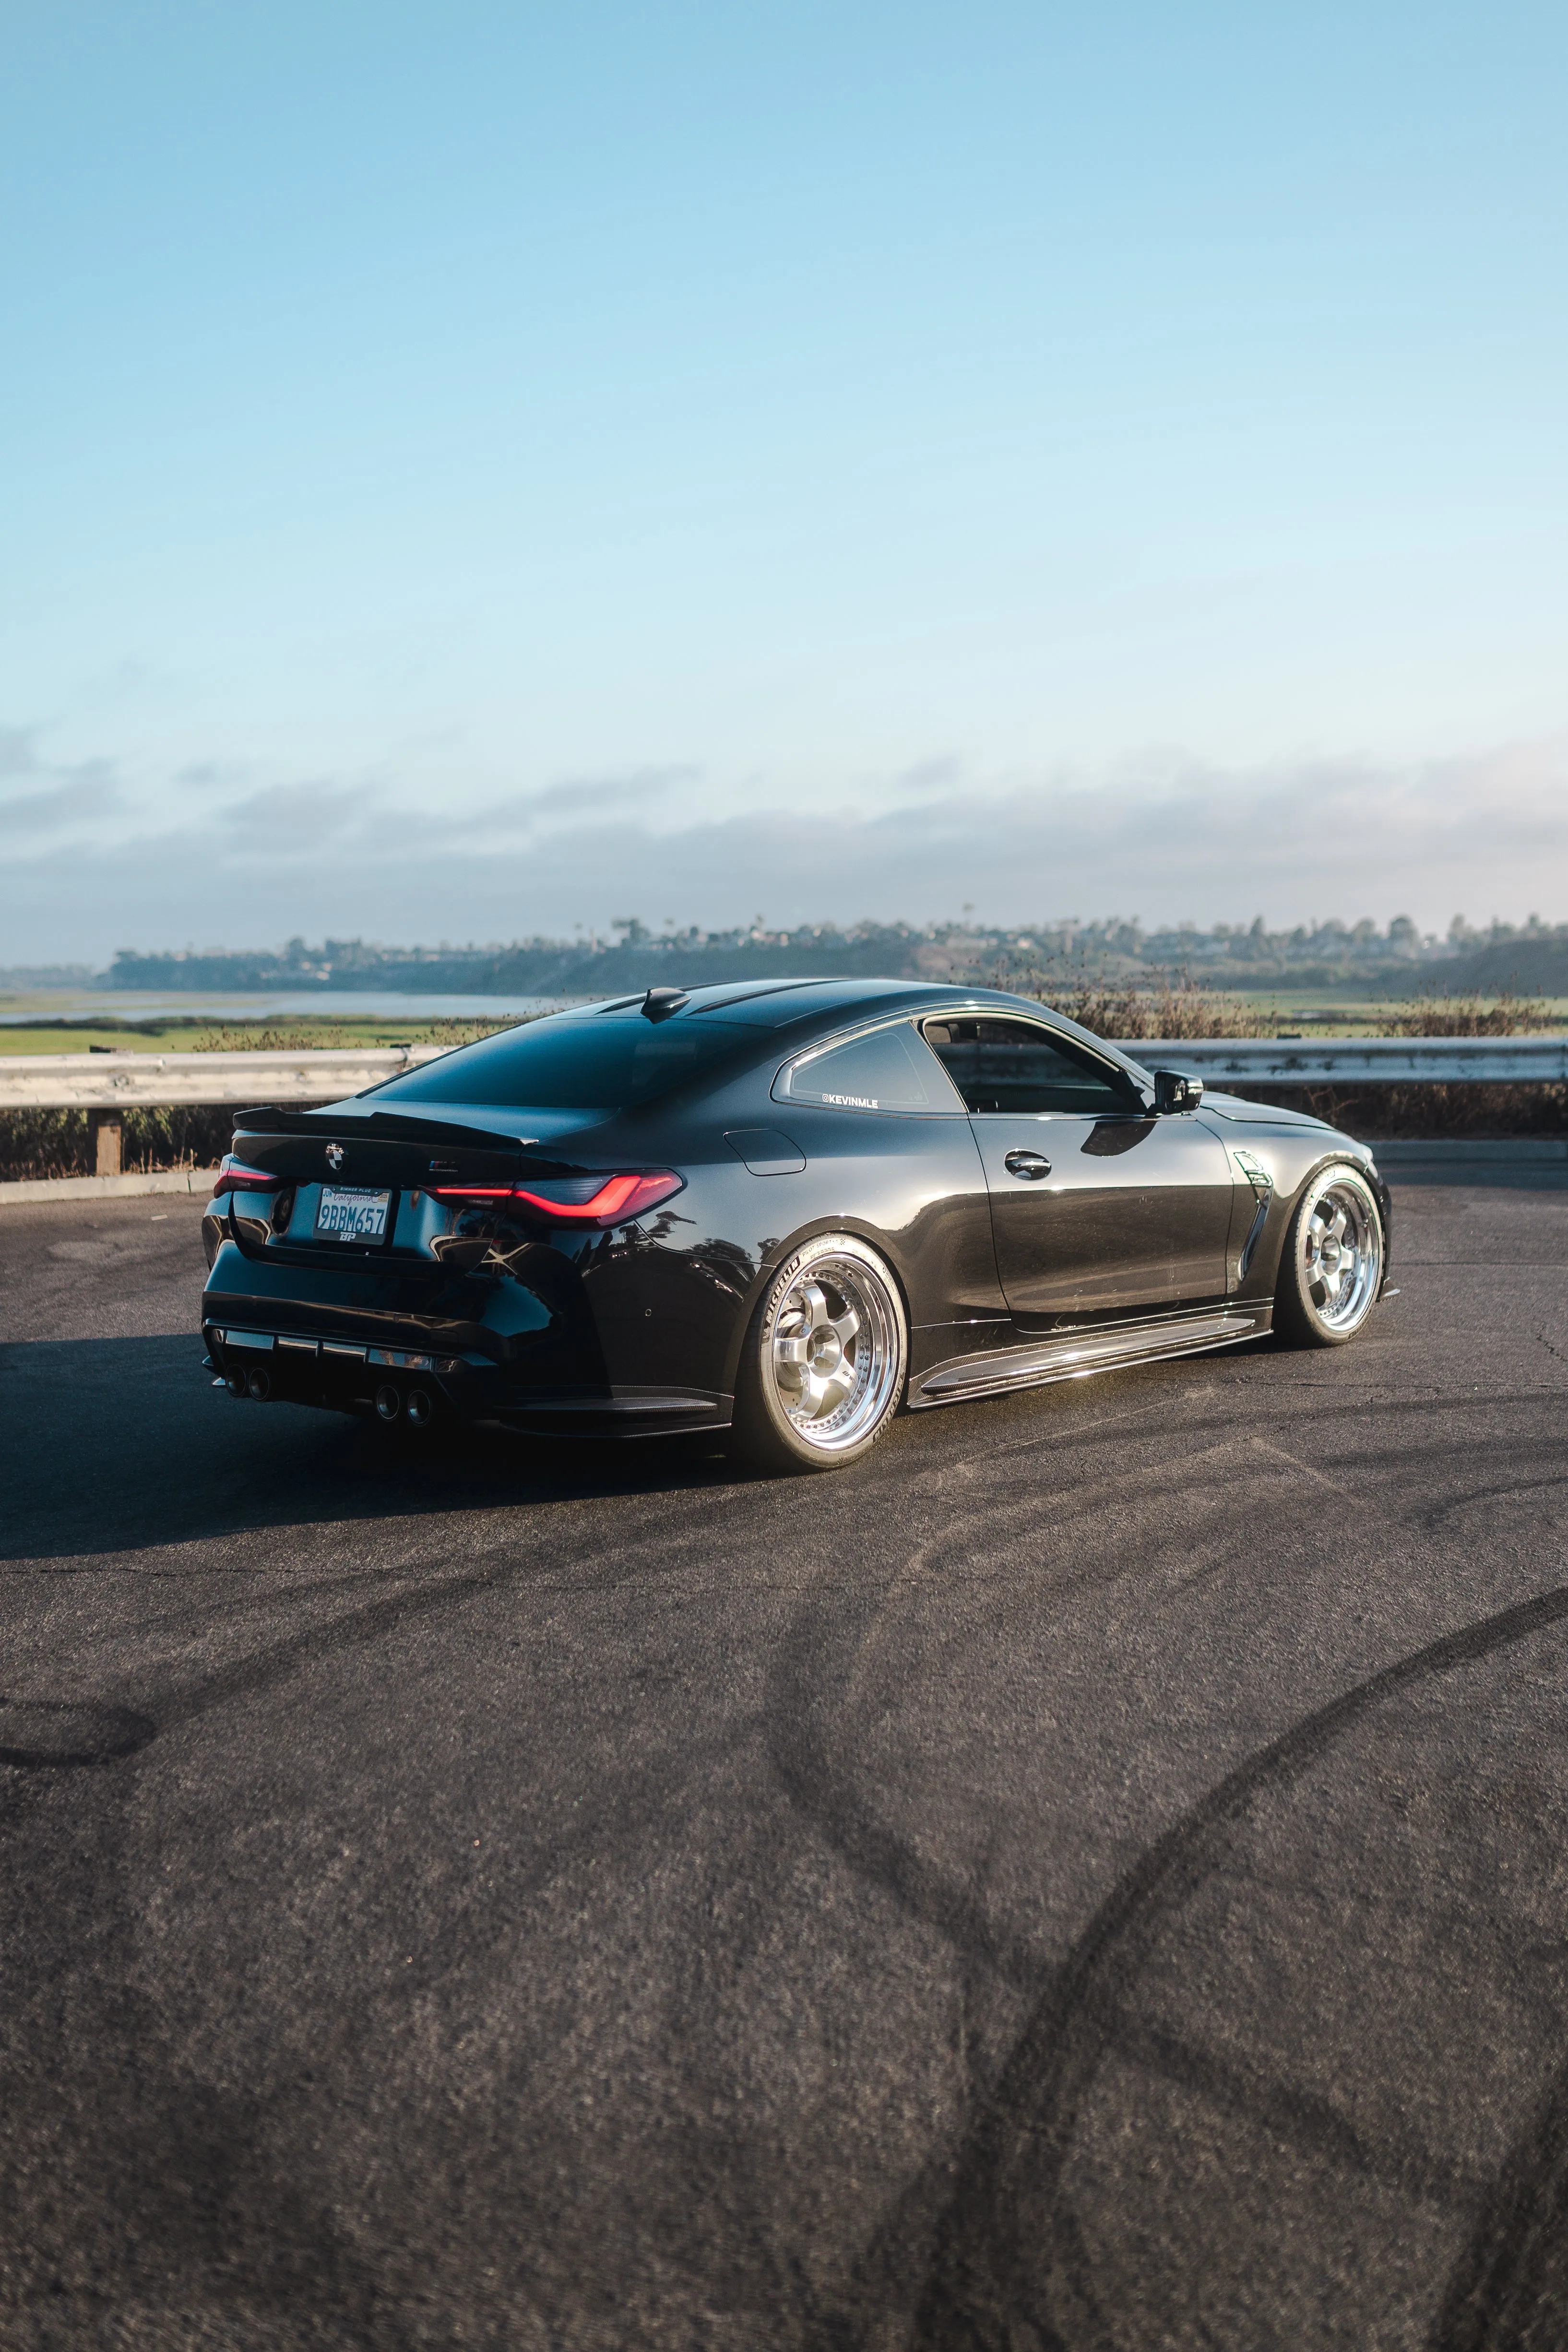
[0,1037,1568,1113]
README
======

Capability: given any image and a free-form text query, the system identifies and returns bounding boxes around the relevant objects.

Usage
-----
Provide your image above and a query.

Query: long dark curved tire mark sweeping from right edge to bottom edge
[915,1585,1568,2352]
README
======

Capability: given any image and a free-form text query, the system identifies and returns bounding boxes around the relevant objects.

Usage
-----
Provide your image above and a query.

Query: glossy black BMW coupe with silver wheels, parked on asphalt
[202,981,1390,1470]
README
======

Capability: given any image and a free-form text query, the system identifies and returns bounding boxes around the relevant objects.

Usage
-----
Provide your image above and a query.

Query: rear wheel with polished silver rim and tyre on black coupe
[731,1233,910,1470]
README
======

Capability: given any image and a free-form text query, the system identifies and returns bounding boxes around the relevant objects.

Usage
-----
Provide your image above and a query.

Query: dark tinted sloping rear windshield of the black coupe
[364,1014,757,1113]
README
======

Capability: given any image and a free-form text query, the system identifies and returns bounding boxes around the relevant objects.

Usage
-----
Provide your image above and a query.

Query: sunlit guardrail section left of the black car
[0,1044,451,1110]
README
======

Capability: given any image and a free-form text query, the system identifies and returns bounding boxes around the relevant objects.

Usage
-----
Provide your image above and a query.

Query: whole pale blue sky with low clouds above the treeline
[0,0,1568,962]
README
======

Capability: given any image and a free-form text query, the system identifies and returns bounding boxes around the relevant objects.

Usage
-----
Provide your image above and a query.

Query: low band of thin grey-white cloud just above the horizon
[0,738,1568,962]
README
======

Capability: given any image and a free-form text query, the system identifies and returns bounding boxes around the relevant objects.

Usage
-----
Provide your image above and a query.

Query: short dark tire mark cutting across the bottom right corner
[1427,2067,1568,2352]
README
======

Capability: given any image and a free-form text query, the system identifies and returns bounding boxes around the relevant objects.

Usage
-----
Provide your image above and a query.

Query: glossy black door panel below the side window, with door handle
[971,1113,1234,1324]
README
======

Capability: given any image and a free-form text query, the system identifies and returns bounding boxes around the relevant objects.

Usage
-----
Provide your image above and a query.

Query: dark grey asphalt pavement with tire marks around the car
[0,1174,1568,2352]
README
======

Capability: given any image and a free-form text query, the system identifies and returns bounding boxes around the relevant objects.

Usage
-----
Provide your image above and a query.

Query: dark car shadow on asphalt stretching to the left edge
[0,1338,755,1559]
